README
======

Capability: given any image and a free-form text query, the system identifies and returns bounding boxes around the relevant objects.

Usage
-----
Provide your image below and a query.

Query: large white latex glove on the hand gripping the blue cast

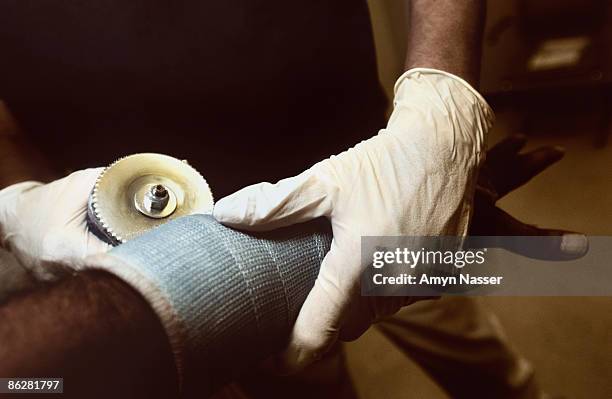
[214,69,493,372]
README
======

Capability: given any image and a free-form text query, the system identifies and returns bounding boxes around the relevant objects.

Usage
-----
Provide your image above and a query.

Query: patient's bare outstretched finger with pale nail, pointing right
[470,207,589,260]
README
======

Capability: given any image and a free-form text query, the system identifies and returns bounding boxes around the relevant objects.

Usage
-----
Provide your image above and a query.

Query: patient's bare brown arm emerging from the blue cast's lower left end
[0,272,176,398]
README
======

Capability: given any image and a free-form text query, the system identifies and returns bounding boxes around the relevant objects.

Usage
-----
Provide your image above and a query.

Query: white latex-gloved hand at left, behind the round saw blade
[0,168,110,280]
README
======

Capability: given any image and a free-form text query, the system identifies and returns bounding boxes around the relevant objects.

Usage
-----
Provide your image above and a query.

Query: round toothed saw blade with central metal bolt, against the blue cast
[88,153,214,245]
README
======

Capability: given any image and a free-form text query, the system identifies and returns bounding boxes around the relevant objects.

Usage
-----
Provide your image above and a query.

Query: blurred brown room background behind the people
[347,0,612,399]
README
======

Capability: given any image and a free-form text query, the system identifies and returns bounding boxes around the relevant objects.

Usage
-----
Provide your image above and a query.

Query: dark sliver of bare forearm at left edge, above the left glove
[0,100,58,189]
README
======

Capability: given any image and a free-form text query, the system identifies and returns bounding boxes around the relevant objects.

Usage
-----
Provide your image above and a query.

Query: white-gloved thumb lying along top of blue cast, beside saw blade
[213,170,331,231]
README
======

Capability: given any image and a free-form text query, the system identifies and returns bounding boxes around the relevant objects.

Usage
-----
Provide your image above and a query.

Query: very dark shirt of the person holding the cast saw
[0,0,386,197]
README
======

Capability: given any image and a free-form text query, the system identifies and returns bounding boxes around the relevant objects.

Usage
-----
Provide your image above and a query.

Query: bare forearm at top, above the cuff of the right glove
[405,0,486,87]
